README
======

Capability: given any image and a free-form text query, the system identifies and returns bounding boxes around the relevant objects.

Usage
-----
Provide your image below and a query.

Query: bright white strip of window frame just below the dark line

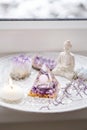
[0,20,87,29]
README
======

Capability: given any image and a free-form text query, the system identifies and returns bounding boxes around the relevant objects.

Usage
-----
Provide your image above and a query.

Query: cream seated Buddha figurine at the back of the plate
[53,40,75,80]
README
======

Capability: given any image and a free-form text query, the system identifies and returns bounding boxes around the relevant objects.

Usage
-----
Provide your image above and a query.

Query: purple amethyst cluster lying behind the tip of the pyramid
[33,56,56,70]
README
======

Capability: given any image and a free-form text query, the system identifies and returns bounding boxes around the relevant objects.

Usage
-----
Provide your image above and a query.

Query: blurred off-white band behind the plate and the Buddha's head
[0,29,87,53]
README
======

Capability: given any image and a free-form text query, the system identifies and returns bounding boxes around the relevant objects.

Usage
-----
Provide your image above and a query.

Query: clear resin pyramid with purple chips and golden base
[28,64,59,98]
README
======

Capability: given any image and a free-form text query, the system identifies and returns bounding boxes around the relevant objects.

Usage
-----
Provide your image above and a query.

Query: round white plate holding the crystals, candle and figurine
[0,53,87,113]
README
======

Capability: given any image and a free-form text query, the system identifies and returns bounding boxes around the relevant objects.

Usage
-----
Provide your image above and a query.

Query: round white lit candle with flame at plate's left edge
[0,79,24,102]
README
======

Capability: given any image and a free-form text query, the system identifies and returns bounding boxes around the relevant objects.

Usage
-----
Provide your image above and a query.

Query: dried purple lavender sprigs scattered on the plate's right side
[41,78,87,109]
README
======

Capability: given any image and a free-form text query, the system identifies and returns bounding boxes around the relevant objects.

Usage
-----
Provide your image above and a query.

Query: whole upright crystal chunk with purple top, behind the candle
[10,55,32,80]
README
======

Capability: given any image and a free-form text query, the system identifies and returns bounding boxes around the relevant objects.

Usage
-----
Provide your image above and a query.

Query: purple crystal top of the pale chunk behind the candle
[12,54,31,64]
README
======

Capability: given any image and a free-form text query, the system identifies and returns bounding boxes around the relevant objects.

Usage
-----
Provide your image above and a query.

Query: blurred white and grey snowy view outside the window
[0,0,87,19]
